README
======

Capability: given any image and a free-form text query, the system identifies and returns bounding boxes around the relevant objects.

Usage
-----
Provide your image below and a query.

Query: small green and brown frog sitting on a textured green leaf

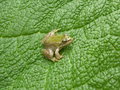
[42,29,73,62]
